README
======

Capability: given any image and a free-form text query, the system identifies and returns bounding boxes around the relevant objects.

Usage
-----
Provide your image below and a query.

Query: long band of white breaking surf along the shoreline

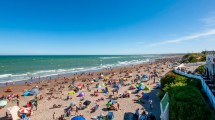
[0,59,149,83]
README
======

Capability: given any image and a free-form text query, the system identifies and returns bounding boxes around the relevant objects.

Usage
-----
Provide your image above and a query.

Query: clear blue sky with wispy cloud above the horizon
[0,0,215,55]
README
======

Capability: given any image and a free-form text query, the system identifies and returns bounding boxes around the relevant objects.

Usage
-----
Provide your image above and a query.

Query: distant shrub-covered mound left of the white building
[181,52,206,63]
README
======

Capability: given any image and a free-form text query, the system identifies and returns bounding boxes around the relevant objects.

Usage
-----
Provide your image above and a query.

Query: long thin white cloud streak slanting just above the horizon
[148,29,215,47]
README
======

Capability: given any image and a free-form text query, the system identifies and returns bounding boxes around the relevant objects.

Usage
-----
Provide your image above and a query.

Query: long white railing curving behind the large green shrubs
[174,69,215,110]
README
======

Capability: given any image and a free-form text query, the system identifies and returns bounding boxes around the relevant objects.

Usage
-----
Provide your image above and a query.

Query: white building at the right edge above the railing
[205,51,215,83]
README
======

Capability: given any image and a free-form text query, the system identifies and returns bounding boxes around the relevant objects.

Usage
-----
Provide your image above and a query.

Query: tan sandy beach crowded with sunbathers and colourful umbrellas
[0,58,181,120]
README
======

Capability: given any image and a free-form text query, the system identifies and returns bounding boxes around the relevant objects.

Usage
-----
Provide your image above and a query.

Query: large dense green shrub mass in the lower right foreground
[159,72,214,120]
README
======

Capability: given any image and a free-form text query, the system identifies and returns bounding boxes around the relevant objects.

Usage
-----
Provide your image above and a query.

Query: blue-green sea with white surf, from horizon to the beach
[0,55,165,83]
